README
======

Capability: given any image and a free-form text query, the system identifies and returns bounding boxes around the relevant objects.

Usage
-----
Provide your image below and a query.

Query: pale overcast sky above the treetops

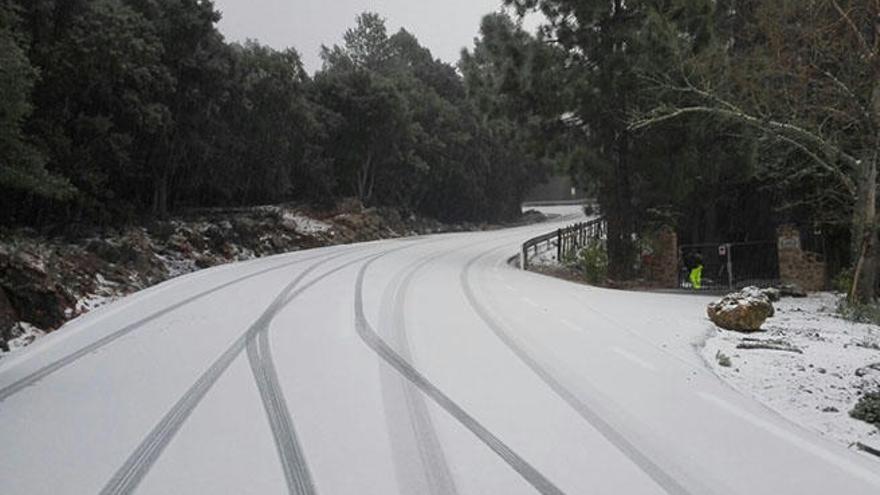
[214,0,537,73]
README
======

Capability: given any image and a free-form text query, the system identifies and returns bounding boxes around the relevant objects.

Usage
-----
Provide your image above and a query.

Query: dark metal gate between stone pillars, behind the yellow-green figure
[678,241,779,290]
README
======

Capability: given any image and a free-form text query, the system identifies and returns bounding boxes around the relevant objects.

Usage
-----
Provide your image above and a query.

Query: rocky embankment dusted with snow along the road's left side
[0,203,542,356]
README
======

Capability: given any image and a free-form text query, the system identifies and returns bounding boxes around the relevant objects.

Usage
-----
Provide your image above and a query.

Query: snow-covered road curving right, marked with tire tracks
[0,210,880,495]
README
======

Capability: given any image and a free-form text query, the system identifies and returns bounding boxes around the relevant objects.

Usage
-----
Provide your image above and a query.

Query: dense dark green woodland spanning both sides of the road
[0,0,880,301]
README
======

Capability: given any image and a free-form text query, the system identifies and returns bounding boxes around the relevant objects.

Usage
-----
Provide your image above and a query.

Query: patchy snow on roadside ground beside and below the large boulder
[702,293,880,452]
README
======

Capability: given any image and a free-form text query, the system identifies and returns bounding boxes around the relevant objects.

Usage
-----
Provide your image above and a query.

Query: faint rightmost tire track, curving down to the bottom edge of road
[460,248,705,495]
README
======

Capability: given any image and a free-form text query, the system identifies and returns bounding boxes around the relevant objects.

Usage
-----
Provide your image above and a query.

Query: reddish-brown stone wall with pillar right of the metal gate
[776,225,826,292]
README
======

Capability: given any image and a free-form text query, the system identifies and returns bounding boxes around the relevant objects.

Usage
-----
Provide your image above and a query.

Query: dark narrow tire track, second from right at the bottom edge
[354,250,564,495]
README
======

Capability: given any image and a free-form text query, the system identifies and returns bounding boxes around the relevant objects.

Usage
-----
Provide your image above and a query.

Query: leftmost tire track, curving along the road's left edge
[0,255,336,402]
